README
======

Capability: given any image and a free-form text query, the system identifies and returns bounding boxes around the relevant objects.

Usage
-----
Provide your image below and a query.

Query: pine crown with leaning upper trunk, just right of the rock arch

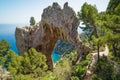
[78,3,98,37]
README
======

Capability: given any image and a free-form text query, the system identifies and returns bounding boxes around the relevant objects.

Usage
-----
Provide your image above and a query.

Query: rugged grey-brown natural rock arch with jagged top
[15,3,88,69]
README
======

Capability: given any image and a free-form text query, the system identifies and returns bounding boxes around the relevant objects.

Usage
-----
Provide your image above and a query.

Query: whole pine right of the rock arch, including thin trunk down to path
[78,3,103,61]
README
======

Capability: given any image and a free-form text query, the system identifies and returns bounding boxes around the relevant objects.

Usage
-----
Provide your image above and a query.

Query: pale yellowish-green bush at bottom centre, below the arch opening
[53,50,79,80]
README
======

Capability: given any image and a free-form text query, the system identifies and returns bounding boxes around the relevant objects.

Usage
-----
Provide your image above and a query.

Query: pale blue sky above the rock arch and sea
[0,0,109,24]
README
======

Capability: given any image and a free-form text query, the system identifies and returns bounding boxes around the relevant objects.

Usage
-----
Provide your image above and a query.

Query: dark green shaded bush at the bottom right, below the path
[92,56,114,80]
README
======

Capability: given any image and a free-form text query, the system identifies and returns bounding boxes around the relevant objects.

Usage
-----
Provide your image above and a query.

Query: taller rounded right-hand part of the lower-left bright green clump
[22,48,48,76]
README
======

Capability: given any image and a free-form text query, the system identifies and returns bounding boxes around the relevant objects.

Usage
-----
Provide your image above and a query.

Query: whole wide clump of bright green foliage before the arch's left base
[8,48,48,79]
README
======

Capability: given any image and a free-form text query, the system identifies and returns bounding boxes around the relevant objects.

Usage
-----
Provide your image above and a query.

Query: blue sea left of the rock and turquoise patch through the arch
[0,24,61,63]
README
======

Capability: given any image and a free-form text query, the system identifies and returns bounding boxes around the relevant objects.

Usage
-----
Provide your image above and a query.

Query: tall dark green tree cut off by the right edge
[102,0,120,56]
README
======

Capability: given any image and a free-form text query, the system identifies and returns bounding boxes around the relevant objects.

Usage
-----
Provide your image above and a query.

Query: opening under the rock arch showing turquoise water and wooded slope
[51,40,75,63]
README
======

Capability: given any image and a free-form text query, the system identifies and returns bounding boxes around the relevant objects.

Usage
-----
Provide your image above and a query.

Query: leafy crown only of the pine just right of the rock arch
[78,3,98,27]
